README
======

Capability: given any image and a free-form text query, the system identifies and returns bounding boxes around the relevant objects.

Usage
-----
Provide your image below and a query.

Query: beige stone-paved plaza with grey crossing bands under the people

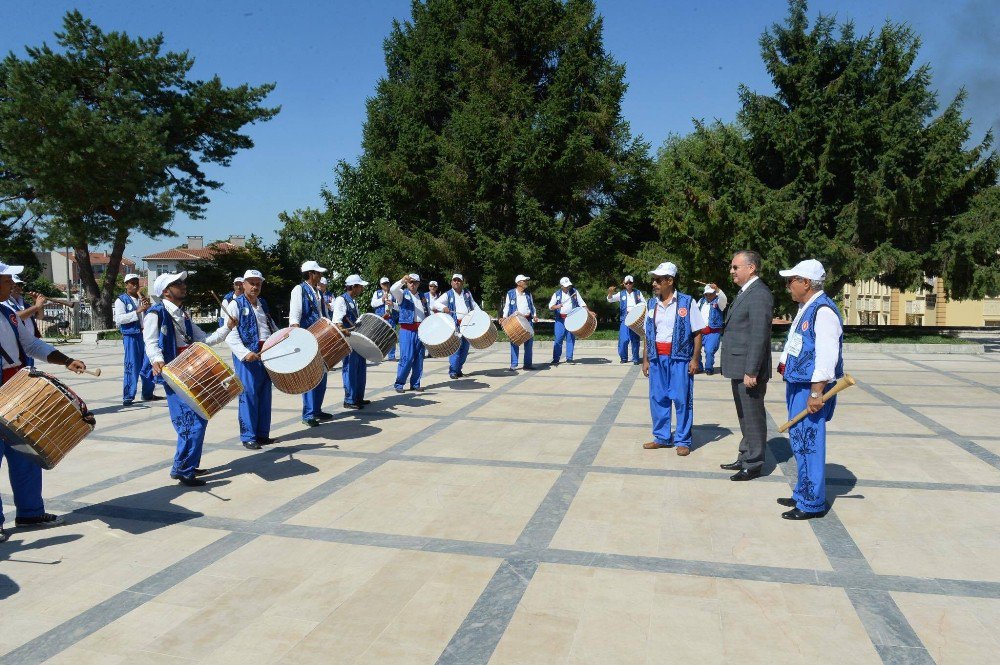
[0,344,1000,665]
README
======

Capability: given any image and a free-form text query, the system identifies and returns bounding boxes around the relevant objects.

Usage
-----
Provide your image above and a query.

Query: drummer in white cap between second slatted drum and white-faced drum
[226,270,278,450]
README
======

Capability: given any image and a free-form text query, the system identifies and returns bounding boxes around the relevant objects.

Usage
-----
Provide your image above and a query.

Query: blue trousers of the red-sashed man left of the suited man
[649,356,694,448]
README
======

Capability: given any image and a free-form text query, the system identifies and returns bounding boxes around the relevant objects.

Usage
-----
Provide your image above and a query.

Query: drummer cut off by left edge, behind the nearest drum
[0,263,87,543]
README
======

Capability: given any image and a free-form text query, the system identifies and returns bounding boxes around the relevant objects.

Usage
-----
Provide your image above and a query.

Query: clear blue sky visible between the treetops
[0,0,1000,264]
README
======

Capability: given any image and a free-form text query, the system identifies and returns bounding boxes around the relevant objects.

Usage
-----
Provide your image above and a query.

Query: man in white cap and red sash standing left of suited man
[642,261,705,457]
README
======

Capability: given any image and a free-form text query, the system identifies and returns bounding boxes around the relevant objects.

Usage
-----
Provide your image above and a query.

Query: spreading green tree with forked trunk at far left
[0,11,279,326]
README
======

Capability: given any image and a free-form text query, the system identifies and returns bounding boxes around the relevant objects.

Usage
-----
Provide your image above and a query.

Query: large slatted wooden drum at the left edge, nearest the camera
[0,368,94,469]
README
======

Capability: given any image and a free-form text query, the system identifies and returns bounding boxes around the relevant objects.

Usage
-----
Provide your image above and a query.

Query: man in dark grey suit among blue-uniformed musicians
[721,250,774,480]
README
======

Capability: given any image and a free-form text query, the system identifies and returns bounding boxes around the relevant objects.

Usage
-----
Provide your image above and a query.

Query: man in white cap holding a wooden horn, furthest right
[778,259,844,520]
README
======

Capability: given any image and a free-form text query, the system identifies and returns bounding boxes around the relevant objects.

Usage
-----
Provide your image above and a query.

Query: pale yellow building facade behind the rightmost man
[841,277,1000,327]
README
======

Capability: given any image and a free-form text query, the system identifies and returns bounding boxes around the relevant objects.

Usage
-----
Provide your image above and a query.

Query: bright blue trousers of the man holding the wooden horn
[785,383,837,513]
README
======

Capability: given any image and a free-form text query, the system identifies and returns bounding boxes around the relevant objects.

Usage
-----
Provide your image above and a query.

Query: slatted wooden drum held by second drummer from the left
[163,342,243,420]
